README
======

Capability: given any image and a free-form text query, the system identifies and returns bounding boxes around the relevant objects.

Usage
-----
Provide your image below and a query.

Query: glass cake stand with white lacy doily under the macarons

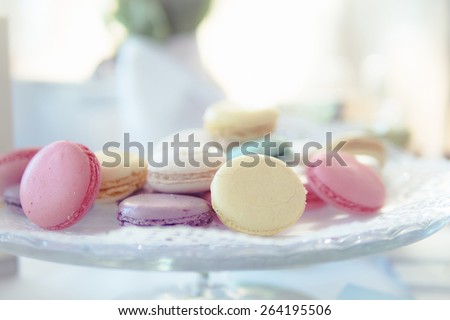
[0,150,450,299]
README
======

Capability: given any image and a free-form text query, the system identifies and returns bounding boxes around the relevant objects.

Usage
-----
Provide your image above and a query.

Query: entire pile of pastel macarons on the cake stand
[0,102,385,236]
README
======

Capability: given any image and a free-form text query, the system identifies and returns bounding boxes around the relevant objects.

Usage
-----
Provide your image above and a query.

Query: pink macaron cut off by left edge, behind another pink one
[0,148,39,194]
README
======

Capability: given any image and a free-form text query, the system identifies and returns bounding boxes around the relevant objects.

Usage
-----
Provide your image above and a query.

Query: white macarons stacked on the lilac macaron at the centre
[117,129,223,227]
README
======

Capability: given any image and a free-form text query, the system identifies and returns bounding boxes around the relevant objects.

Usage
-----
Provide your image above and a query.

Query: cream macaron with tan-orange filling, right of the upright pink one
[95,150,148,202]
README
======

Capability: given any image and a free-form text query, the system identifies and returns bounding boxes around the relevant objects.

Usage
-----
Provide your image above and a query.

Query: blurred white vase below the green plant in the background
[116,37,221,146]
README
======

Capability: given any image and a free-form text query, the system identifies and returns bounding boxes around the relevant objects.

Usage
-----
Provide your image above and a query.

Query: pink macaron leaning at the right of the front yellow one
[306,153,386,215]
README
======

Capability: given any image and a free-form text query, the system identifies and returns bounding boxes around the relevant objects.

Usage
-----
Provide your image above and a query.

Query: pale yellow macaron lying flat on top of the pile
[203,101,279,141]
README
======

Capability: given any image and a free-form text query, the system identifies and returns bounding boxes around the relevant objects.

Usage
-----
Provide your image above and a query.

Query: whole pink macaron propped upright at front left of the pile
[20,141,100,230]
